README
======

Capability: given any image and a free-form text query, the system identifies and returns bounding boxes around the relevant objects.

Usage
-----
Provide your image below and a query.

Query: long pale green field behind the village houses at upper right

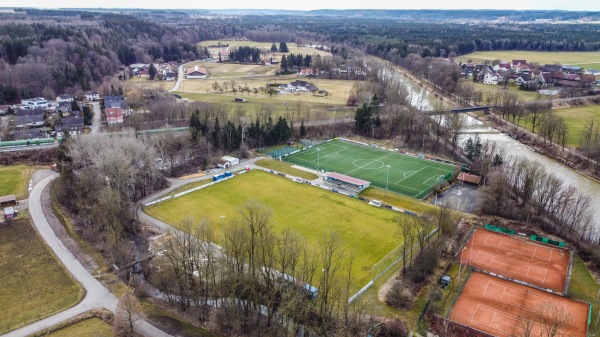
[455,50,600,69]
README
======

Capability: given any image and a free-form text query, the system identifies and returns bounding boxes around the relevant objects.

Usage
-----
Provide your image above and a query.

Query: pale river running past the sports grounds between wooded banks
[394,67,600,229]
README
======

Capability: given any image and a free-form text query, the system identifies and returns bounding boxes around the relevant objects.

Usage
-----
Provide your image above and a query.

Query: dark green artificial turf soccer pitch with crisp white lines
[282,140,456,199]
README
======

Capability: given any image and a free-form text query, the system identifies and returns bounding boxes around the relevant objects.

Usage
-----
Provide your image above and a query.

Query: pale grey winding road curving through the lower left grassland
[3,174,171,337]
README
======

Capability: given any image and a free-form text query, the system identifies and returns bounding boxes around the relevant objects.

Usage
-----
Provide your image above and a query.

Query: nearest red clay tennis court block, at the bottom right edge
[449,272,590,337]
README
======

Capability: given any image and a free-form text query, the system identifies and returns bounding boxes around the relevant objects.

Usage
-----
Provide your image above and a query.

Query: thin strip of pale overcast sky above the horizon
[0,0,600,11]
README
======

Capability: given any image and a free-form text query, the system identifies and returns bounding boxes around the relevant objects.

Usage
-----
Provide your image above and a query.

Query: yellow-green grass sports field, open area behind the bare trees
[145,170,404,289]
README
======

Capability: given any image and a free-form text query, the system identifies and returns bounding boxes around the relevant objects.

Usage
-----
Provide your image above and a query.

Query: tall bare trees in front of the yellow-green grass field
[148,201,406,336]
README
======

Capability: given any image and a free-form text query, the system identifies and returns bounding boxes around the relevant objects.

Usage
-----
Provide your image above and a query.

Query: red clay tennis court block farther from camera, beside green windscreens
[457,228,570,293]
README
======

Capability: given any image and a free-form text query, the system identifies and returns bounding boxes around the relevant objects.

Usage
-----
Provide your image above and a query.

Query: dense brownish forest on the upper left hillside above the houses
[0,9,220,104]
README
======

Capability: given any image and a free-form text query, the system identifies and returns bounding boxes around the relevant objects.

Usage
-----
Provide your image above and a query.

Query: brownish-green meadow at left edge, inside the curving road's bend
[0,212,83,334]
